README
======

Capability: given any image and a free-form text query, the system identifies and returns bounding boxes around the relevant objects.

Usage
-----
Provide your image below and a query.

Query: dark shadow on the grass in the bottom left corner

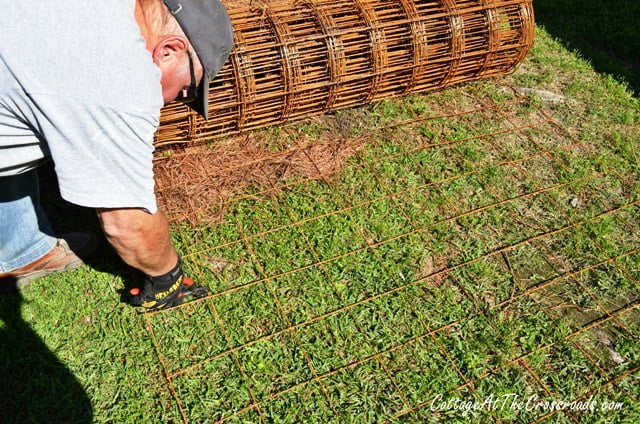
[0,293,93,423]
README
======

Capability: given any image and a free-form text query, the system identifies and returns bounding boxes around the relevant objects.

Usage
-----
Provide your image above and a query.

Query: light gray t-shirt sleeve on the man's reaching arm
[33,94,158,213]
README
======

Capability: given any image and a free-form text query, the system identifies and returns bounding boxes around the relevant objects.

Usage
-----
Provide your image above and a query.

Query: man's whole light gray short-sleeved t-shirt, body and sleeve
[0,0,163,213]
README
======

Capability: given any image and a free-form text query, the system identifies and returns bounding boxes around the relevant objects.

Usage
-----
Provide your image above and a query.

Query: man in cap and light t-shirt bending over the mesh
[0,0,233,308]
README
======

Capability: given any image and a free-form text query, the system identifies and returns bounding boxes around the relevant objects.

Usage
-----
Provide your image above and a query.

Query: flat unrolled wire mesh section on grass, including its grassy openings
[144,81,640,422]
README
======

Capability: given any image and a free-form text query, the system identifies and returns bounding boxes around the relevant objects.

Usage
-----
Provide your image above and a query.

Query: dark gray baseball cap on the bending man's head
[163,0,233,119]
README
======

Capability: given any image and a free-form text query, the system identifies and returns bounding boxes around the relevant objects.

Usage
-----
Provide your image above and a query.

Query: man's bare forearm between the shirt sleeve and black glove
[97,209,178,276]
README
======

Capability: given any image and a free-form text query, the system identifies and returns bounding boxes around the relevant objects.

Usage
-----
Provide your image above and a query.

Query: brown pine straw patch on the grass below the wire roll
[155,134,366,226]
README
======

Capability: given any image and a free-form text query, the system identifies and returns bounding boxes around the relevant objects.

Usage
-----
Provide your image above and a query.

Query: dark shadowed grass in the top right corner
[533,0,640,95]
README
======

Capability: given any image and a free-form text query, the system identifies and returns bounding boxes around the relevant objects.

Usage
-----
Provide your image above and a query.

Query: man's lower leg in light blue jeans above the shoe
[0,169,58,273]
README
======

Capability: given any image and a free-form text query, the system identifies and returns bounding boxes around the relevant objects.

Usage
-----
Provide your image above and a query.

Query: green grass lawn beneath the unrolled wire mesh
[0,11,640,423]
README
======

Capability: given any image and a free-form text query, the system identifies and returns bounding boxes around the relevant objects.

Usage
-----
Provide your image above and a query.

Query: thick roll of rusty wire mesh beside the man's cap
[155,0,534,146]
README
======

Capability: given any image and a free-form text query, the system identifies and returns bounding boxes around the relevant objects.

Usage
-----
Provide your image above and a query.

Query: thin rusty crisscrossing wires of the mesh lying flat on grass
[144,78,640,422]
